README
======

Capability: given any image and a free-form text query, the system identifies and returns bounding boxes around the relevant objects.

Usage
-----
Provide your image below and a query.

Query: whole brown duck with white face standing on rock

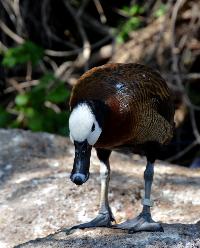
[69,63,175,233]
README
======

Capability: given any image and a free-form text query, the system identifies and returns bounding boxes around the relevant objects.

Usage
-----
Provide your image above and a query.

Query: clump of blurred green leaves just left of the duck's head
[0,70,70,136]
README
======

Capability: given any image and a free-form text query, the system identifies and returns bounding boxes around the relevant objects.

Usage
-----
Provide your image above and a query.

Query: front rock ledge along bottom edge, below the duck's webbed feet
[16,224,200,248]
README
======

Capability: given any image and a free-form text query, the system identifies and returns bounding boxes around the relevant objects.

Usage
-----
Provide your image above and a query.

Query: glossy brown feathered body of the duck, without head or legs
[70,64,174,151]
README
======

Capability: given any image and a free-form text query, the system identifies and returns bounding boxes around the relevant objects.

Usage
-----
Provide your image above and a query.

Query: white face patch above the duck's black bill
[69,103,102,145]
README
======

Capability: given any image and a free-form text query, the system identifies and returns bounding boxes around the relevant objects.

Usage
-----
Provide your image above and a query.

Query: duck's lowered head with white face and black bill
[69,102,102,185]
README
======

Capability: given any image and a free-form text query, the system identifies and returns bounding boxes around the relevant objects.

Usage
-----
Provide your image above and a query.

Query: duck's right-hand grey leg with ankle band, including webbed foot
[114,161,163,233]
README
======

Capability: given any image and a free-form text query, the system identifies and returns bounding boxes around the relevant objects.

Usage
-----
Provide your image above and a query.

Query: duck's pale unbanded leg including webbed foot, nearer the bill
[70,149,114,230]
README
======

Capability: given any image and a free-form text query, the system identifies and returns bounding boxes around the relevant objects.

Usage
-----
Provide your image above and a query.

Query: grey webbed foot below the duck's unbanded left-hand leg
[65,212,115,234]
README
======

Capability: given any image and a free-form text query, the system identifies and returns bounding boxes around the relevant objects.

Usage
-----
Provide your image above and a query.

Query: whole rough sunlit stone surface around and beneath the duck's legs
[0,130,200,248]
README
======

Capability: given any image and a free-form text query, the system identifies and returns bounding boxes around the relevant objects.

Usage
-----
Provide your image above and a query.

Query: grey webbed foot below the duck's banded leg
[113,213,164,233]
